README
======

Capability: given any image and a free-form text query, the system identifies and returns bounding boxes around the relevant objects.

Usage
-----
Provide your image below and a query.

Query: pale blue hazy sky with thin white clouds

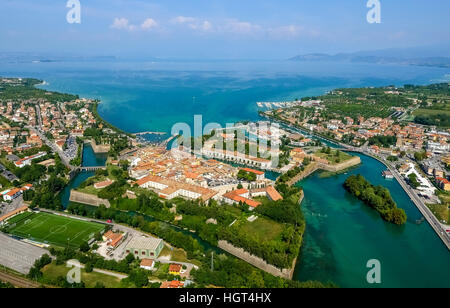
[0,0,450,59]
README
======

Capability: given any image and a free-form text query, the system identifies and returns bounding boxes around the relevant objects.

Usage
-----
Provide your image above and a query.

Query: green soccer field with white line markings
[8,213,105,248]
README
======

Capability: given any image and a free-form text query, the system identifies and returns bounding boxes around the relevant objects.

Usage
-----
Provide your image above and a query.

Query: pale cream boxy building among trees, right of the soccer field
[125,236,164,259]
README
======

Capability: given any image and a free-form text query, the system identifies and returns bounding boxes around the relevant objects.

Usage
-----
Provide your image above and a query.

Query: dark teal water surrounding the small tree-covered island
[295,155,450,287]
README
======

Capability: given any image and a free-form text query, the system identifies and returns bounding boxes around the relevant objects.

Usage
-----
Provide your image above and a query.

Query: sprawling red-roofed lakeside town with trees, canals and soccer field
[0,78,450,288]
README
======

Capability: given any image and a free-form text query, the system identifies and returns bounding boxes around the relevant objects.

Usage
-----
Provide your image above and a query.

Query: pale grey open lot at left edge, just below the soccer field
[0,234,47,274]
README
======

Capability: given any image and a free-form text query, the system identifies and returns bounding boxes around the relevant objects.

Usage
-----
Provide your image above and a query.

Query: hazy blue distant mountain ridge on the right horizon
[289,50,450,68]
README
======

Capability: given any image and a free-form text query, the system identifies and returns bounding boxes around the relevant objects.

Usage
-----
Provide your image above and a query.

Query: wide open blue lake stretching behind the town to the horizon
[0,61,450,132]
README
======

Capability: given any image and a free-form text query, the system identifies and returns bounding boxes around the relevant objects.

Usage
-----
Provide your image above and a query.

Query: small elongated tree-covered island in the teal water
[344,174,406,225]
